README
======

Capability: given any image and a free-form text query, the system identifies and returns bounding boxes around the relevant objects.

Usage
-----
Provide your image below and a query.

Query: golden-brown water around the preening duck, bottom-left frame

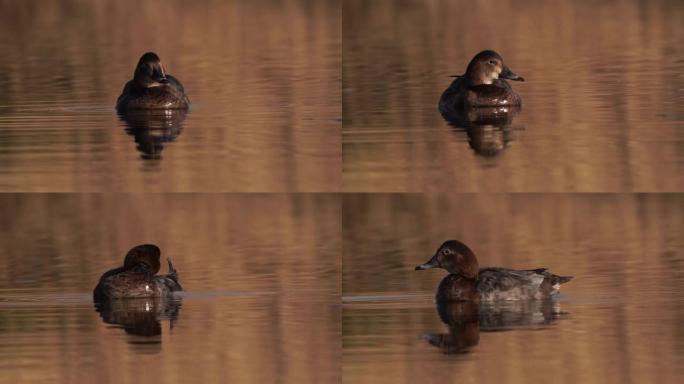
[0,194,341,383]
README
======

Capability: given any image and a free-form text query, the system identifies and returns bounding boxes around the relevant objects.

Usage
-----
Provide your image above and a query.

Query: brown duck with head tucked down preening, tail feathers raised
[93,244,183,302]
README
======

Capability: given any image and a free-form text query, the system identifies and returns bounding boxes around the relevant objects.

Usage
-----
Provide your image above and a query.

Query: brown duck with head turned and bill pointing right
[439,49,525,117]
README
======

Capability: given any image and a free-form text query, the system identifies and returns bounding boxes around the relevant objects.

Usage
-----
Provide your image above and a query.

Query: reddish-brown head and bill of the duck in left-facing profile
[415,240,480,279]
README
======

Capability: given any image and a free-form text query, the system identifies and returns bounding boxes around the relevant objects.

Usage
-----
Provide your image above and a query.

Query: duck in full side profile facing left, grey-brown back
[415,240,573,302]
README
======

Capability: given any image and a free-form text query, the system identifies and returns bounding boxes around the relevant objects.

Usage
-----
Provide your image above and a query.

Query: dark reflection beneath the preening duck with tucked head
[95,297,181,344]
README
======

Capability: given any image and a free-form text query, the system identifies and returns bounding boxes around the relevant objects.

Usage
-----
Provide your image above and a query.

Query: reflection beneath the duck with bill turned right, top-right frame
[442,106,521,157]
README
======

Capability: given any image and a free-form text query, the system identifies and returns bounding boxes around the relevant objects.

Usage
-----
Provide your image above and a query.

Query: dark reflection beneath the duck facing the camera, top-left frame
[119,109,188,160]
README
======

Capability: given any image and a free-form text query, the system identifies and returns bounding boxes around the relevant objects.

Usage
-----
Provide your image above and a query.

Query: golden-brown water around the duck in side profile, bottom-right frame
[342,194,684,383]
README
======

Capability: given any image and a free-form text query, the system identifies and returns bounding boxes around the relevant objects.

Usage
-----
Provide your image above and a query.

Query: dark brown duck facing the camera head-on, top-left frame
[116,52,190,112]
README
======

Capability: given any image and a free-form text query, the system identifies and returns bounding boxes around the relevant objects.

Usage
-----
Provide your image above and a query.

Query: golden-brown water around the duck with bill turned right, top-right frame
[342,0,684,192]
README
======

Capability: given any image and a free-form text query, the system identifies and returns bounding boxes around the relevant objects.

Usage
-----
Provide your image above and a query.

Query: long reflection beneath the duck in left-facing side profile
[423,300,568,354]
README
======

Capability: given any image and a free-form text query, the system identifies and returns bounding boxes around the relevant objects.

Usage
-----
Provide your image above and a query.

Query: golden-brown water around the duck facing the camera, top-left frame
[0,0,341,192]
